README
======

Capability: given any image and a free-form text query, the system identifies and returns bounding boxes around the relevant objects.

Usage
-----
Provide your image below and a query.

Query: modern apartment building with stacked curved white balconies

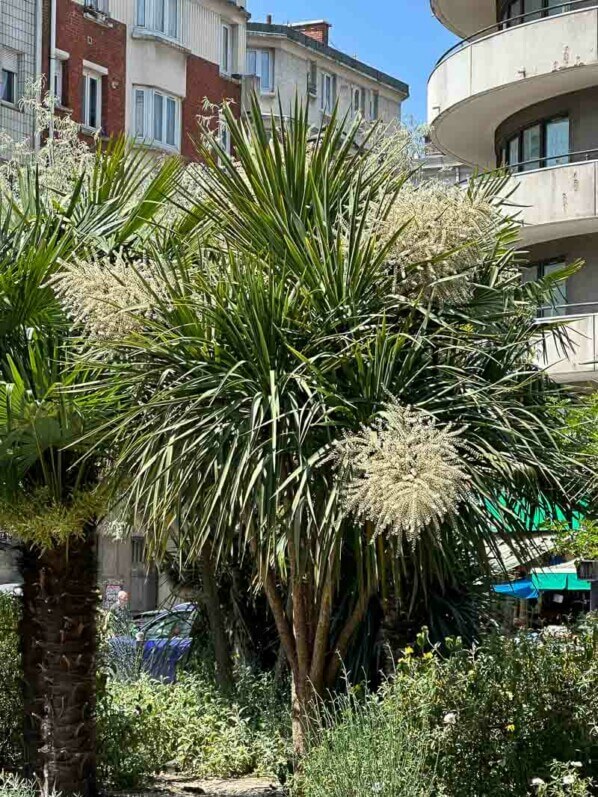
[428,0,598,382]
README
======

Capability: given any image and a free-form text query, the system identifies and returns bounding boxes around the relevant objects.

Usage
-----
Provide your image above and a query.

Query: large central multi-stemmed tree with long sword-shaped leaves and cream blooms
[86,100,588,751]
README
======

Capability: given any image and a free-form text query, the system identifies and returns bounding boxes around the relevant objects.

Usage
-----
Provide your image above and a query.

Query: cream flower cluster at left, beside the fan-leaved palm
[52,254,164,340]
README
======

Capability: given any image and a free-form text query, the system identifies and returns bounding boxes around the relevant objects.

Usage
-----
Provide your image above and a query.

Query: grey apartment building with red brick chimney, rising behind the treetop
[246,17,409,126]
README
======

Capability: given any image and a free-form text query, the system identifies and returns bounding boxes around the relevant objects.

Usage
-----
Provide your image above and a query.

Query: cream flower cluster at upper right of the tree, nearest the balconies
[381,181,499,300]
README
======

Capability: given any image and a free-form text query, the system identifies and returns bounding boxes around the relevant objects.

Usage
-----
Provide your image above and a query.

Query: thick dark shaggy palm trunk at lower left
[21,524,98,797]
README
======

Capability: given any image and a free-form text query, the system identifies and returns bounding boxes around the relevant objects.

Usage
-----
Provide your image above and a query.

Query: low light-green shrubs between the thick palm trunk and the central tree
[98,670,290,788]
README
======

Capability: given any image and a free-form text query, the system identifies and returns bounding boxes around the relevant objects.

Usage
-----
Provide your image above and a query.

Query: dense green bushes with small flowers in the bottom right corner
[296,622,598,797]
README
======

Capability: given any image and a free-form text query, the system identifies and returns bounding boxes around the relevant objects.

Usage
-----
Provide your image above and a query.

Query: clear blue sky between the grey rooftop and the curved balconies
[247,0,456,122]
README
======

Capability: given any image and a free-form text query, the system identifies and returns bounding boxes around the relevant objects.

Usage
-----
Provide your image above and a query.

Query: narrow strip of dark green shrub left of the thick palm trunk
[0,593,22,768]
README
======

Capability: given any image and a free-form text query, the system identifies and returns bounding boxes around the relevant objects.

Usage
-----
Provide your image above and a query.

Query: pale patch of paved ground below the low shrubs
[111,775,283,797]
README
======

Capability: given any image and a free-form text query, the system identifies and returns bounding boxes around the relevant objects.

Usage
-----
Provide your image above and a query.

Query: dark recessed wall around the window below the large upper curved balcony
[495,87,598,162]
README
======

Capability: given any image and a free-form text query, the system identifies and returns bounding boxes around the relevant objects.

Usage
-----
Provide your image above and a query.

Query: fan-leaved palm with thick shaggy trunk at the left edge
[0,141,179,795]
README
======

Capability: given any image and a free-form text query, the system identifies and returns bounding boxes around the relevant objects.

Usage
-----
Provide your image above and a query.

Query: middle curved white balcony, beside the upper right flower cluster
[508,159,598,246]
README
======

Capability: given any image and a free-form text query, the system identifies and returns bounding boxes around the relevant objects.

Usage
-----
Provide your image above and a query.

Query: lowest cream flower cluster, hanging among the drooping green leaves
[336,403,468,545]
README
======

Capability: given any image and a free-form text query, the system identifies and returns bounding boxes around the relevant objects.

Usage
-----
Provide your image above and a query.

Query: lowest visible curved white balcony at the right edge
[536,305,598,382]
